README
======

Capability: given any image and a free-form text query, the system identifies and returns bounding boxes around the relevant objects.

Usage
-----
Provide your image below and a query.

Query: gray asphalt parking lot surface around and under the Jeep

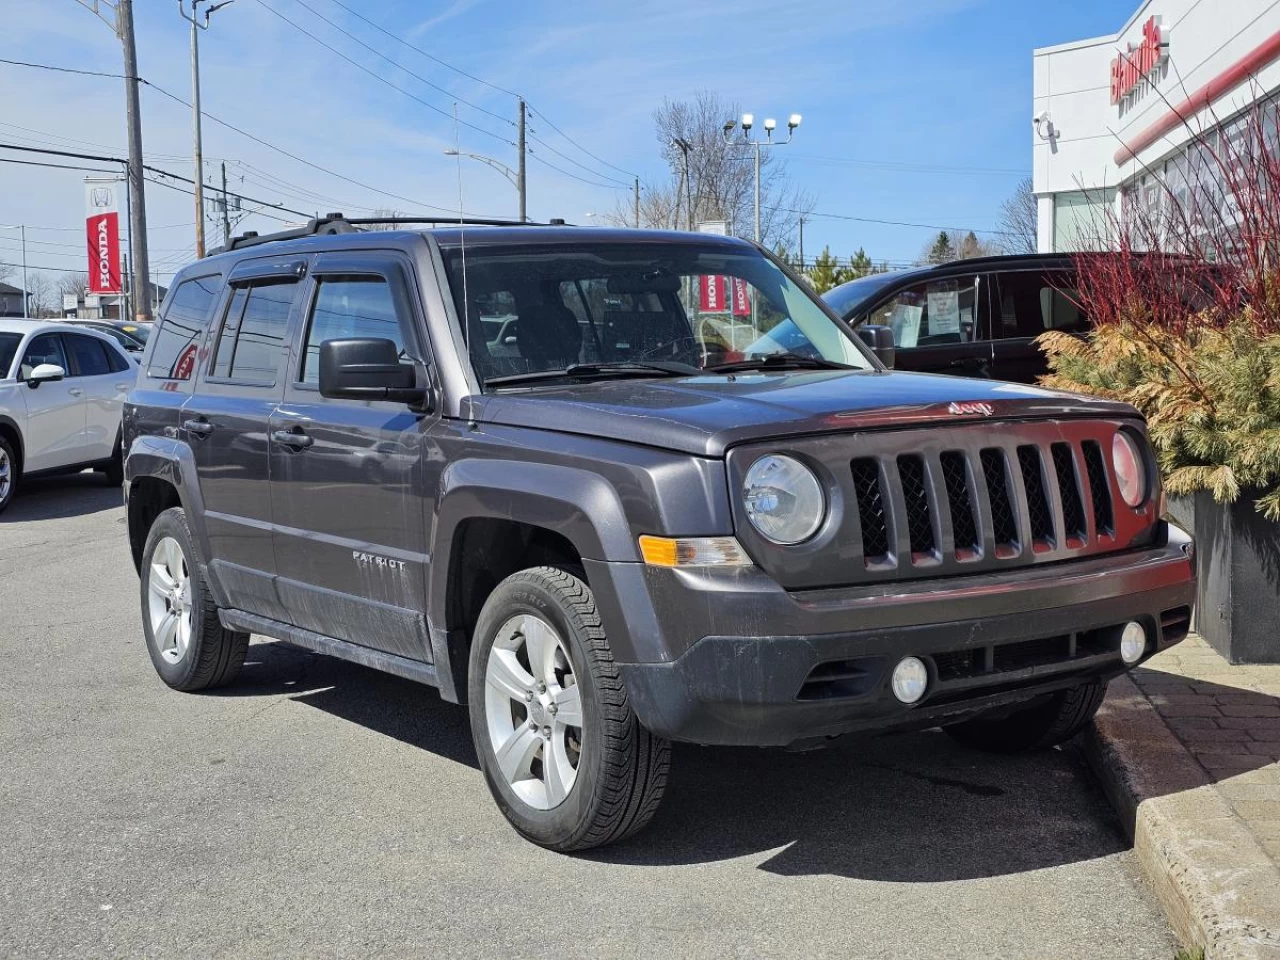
[0,474,1174,960]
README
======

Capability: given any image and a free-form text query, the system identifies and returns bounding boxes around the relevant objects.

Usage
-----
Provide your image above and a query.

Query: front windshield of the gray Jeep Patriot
[444,242,873,383]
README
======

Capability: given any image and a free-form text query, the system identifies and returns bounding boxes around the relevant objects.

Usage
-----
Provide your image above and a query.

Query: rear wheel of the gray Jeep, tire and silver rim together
[142,507,248,690]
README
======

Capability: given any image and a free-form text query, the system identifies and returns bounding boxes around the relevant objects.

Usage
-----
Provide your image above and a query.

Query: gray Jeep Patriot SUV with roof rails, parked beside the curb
[124,215,1194,850]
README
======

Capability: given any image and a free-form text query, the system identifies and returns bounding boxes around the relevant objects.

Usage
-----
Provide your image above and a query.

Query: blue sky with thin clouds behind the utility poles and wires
[0,0,1135,285]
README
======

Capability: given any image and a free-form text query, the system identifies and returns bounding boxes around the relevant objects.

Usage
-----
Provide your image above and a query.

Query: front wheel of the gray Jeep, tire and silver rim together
[468,567,671,852]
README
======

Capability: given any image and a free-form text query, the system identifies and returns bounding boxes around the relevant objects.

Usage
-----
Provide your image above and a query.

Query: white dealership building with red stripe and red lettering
[1032,0,1280,252]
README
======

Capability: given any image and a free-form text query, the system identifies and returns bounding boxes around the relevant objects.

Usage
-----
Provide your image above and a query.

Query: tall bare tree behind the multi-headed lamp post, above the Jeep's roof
[608,91,814,247]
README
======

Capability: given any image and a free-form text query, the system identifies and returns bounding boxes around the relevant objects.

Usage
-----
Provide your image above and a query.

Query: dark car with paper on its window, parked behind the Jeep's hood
[823,253,1089,383]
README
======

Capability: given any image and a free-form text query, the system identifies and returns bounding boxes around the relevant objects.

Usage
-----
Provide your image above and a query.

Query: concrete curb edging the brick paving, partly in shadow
[1083,676,1280,960]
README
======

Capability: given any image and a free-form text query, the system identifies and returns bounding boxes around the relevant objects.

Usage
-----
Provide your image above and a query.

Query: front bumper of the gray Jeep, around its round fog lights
[588,527,1196,746]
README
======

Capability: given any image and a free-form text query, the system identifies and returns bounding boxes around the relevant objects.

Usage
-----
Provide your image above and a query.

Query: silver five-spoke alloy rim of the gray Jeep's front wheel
[485,614,582,810]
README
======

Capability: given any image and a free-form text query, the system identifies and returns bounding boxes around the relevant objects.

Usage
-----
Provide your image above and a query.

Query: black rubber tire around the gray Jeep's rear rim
[142,507,248,691]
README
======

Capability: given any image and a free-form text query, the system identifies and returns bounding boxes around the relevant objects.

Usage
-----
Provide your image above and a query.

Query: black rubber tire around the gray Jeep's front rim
[468,567,671,852]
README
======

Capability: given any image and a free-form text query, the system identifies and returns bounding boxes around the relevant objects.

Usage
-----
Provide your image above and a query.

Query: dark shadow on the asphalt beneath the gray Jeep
[221,643,1126,882]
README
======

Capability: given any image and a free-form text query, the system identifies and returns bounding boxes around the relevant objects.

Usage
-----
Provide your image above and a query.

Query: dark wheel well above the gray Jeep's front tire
[444,517,586,699]
